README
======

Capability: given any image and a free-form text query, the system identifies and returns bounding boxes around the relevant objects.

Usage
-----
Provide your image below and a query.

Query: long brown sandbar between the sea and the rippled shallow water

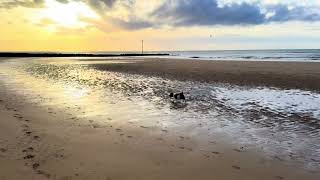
[89,58,320,91]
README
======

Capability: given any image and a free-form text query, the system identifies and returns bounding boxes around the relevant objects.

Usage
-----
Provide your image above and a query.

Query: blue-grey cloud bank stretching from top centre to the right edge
[152,0,320,26]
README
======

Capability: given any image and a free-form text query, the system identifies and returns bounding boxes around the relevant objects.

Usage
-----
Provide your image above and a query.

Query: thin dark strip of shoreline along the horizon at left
[0,52,170,57]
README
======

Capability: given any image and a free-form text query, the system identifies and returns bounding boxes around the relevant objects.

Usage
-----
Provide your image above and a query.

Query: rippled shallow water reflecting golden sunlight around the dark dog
[0,58,320,169]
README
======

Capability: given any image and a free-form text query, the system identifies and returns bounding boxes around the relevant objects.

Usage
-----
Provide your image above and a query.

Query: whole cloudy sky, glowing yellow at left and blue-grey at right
[0,0,320,52]
